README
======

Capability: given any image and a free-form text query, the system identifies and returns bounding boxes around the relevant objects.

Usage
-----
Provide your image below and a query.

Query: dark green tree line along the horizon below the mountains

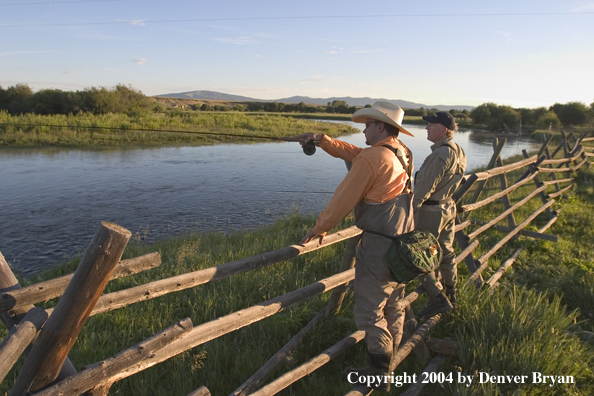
[0,84,594,131]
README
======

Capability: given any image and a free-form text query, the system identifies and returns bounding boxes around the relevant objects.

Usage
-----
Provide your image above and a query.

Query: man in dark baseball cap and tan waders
[413,111,466,317]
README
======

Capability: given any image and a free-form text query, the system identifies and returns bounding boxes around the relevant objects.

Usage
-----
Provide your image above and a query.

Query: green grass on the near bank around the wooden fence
[0,141,594,396]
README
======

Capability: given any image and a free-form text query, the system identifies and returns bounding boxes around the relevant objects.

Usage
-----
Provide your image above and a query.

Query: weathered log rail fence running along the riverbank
[0,134,594,396]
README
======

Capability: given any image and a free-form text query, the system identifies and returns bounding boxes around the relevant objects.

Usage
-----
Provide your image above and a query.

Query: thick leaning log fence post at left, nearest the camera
[10,222,132,396]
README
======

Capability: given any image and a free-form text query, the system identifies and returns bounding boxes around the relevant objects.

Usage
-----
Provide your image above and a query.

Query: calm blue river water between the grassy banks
[0,124,538,277]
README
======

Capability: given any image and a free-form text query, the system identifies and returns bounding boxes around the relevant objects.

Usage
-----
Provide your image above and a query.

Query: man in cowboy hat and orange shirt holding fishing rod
[297,102,414,391]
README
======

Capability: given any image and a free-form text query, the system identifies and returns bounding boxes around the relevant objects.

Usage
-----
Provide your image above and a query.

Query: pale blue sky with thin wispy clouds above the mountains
[0,0,594,108]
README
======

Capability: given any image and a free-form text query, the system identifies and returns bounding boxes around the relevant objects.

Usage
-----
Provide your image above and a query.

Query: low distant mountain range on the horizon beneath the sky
[157,91,474,111]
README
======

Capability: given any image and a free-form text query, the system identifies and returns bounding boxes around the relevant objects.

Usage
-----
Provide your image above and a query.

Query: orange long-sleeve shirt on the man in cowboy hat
[312,135,408,235]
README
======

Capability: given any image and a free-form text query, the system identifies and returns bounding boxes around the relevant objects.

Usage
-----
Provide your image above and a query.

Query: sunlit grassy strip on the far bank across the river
[0,111,359,148]
